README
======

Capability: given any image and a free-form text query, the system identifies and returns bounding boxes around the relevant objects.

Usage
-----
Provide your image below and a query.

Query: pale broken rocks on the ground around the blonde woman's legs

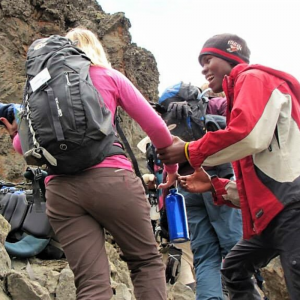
[0,215,195,300]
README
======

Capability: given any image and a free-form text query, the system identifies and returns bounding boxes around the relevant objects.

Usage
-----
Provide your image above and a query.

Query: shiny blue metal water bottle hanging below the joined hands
[165,188,190,243]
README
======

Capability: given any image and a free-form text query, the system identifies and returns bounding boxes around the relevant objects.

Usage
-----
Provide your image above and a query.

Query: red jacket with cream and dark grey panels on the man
[189,64,300,238]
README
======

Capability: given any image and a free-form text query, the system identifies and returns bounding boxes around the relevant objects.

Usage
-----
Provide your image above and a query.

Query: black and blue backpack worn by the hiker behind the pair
[154,82,226,142]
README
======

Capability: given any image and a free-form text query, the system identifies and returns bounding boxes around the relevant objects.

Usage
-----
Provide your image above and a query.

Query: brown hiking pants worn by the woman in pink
[46,168,167,300]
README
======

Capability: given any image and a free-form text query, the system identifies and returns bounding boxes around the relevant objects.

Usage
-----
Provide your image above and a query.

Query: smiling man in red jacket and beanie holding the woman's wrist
[157,34,300,300]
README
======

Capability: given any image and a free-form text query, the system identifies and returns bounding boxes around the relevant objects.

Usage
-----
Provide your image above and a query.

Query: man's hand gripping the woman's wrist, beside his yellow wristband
[156,136,187,165]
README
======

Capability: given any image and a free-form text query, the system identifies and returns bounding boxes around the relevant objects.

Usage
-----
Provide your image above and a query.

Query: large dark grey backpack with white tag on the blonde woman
[16,35,124,174]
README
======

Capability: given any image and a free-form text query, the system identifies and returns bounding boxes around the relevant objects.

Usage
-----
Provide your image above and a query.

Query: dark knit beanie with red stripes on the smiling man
[198,33,250,64]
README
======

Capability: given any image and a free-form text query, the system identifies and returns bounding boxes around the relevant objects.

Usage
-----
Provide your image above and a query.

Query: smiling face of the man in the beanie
[200,54,232,93]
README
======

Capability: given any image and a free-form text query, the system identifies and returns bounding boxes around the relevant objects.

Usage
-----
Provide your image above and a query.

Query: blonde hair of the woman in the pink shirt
[66,27,111,68]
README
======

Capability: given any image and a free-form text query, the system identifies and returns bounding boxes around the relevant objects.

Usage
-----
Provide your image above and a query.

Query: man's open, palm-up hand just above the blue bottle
[178,168,213,193]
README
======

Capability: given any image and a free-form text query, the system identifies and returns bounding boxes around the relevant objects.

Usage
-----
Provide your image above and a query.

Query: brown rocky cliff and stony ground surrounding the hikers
[0,0,288,300]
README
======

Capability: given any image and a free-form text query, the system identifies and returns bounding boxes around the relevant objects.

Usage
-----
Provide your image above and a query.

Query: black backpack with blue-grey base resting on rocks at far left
[0,167,64,259]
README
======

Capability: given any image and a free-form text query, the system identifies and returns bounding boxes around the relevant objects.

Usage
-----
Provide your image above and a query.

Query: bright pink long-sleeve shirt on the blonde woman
[13,66,178,178]
